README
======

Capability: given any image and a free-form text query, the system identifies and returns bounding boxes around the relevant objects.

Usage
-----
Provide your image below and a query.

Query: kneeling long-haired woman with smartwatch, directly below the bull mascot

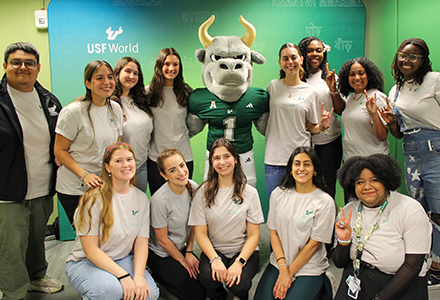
[188,138,264,299]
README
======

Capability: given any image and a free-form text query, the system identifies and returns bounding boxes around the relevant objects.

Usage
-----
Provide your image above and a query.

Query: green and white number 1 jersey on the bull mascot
[189,88,269,153]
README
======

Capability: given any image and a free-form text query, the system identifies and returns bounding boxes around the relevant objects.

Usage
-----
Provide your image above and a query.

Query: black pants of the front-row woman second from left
[147,248,206,300]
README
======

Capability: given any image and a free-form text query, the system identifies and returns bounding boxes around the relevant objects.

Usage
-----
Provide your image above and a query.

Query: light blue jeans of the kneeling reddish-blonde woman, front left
[65,255,159,300]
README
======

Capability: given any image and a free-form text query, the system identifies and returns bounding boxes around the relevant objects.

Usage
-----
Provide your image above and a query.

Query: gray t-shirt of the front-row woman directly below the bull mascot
[188,184,264,258]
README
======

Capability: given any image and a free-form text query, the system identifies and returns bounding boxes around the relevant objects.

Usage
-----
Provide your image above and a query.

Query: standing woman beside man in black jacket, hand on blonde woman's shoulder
[54,60,123,223]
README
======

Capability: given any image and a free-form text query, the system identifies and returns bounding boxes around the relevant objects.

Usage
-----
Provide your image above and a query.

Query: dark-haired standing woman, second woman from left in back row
[112,57,153,192]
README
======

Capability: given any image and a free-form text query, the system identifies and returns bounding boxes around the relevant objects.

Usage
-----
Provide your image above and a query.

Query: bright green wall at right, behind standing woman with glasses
[363,0,440,193]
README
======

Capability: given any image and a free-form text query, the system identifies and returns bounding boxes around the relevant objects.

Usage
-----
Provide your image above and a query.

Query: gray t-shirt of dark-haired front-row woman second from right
[267,187,336,276]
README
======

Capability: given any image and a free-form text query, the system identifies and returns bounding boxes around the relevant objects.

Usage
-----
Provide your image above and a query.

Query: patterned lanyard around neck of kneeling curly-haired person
[353,195,390,278]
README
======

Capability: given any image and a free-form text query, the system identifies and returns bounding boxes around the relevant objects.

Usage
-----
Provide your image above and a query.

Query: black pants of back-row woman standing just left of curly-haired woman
[315,135,342,199]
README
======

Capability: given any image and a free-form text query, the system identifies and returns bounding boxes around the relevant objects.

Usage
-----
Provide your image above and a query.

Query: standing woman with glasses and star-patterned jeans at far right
[383,38,440,284]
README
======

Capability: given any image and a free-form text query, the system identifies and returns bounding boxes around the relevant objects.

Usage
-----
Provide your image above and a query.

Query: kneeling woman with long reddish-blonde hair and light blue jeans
[66,142,159,300]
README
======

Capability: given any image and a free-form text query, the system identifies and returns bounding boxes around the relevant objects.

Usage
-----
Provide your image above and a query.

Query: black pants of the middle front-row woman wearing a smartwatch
[199,251,260,300]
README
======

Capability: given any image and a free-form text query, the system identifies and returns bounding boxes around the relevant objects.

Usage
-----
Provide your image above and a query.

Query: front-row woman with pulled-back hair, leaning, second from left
[147,148,206,300]
